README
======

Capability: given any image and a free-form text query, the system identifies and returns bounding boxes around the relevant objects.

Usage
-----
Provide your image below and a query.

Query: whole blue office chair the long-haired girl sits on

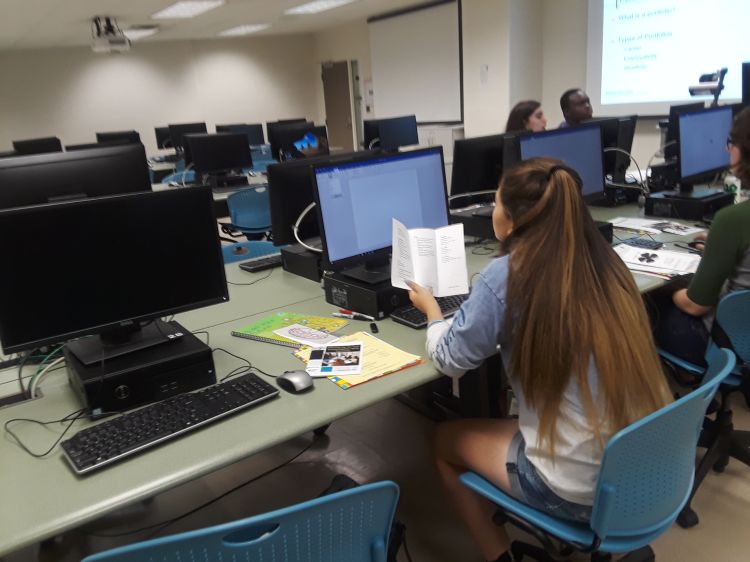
[461,349,735,562]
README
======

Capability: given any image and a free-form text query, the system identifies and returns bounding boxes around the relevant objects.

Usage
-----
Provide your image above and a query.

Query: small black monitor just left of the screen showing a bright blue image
[186,133,253,174]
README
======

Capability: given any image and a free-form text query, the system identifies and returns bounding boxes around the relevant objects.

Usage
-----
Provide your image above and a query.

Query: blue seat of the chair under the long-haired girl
[460,472,687,554]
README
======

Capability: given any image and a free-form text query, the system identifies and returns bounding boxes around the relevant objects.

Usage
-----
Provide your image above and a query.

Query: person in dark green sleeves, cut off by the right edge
[653,108,750,366]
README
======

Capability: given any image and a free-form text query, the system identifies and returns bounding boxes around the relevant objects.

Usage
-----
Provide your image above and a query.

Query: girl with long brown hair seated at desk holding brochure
[409,158,670,561]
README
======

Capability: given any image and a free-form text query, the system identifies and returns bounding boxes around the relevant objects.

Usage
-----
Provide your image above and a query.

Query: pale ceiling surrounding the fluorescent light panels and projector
[0,0,432,50]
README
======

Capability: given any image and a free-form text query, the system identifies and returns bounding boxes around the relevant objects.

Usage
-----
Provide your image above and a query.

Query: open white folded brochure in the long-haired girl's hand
[391,219,469,297]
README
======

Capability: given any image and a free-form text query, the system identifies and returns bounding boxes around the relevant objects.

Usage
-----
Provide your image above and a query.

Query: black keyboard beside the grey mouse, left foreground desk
[62,373,279,474]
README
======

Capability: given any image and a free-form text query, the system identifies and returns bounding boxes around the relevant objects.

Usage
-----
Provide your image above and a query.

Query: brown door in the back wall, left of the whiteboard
[321,61,354,151]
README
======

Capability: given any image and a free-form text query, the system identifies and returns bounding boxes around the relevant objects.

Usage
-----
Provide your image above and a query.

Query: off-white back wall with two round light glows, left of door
[0,35,320,152]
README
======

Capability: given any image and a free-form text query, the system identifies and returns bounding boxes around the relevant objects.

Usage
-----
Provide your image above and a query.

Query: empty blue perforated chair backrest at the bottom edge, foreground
[83,481,398,562]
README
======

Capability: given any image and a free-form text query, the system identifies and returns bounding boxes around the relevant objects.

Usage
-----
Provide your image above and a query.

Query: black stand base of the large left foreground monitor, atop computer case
[66,320,184,365]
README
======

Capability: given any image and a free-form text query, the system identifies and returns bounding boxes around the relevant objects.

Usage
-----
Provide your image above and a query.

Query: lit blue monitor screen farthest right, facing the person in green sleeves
[677,106,732,183]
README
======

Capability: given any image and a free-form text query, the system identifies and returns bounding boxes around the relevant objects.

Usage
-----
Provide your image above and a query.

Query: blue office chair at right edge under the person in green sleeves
[658,291,750,528]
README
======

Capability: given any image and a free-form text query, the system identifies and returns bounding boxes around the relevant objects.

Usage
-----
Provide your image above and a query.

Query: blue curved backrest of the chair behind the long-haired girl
[591,349,735,539]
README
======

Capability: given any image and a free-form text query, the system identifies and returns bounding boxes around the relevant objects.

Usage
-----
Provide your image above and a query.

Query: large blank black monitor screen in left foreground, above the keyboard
[0,188,229,353]
